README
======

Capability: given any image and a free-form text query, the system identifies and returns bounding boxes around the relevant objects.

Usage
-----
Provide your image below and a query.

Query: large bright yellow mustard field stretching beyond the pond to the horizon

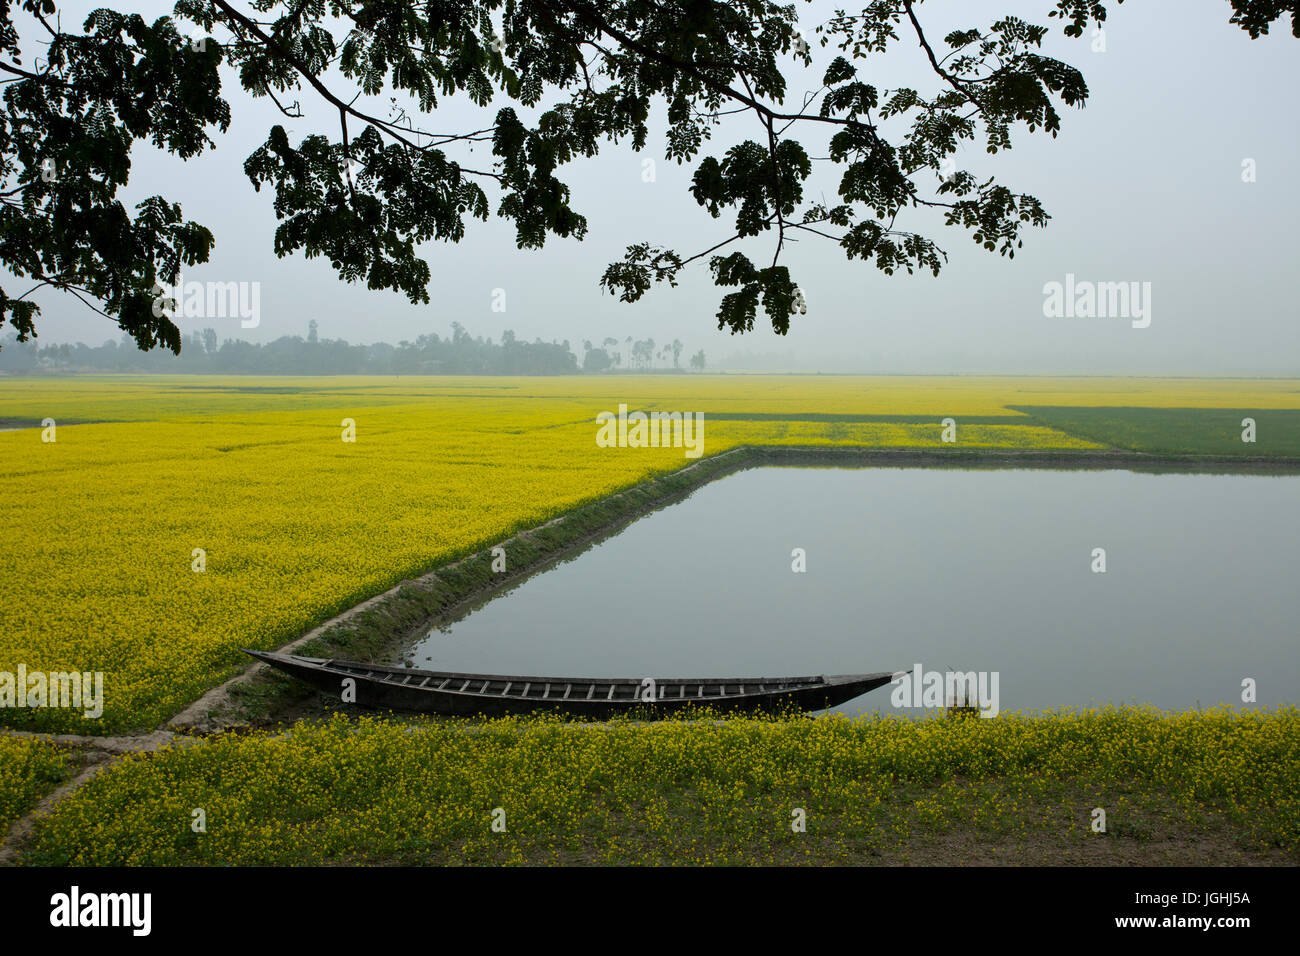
[0,375,1300,734]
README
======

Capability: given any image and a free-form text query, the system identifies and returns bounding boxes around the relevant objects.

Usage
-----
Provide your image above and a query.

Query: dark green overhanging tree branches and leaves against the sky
[0,0,1300,352]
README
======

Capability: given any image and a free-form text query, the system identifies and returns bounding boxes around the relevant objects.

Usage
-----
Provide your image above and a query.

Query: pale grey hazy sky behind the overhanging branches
[5,0,1300,375]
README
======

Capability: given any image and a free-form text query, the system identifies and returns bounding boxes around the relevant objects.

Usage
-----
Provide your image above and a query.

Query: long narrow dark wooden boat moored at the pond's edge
[244,649,893,719]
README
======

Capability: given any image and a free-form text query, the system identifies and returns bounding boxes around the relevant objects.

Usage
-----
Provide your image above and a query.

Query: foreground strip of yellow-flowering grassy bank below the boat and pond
[15,708,1300,865]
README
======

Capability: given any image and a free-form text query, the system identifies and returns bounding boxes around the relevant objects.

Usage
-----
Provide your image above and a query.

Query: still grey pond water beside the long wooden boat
[407,468,1300,714]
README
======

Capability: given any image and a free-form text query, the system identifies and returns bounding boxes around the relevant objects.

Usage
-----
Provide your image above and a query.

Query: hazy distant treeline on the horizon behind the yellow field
[0,320,705,375]
